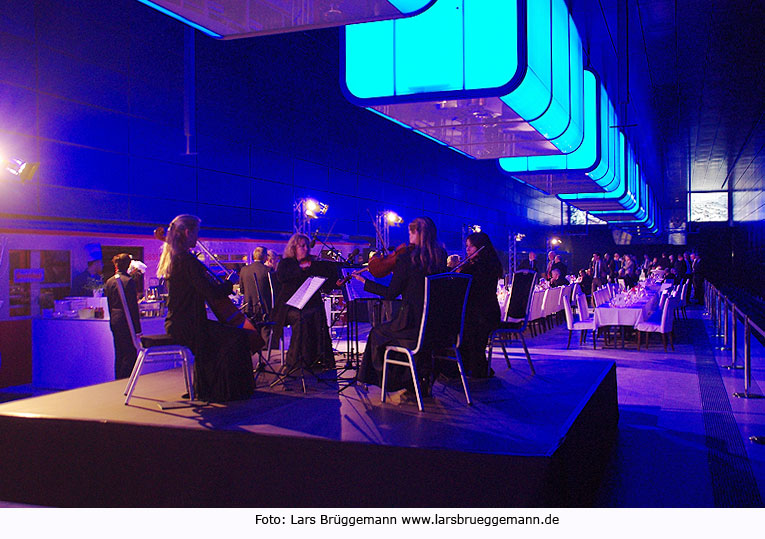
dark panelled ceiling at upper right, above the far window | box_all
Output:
[628,0,765,220]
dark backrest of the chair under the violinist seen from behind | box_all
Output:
[413,273,472,353]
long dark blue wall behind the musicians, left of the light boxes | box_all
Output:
[0,0,560,250]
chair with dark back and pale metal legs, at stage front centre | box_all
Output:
[380,273,473,412]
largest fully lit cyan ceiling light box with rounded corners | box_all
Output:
[342,0,584,158]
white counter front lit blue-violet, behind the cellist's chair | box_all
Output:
[32,318,170,389]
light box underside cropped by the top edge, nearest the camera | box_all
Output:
[138,0,435,39]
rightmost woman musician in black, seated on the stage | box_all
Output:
[457,232,502,378]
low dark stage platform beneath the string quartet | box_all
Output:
[0,359,619,507]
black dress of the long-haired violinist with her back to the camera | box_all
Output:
[357,252,448,391]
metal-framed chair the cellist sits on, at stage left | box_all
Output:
[117,279,194,406]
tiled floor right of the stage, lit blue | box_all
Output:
[508,308,765,507]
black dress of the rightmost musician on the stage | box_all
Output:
[460,258,501,378]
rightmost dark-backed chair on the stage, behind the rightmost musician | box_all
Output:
[489,270,541,374]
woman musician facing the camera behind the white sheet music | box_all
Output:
[273,234,337,373]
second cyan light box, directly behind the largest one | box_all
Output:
[498,70,608,194]
